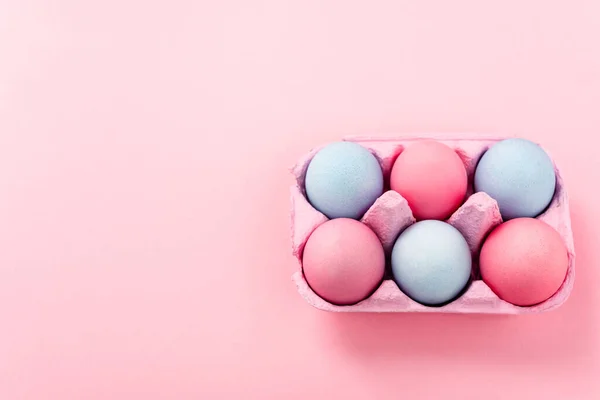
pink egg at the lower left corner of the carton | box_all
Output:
[302,218,385,305]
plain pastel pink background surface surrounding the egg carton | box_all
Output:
[0,0,600,400]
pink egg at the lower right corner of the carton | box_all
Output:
[479,218,569,306]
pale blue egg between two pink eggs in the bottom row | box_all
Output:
[392,220,471,306]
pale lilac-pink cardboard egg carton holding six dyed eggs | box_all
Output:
[291,137,575,314]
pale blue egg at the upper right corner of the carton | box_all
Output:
[474,139,556,221]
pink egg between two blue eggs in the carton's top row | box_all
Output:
[390,140,467,220]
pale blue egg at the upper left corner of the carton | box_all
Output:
[305,142,383,219]
